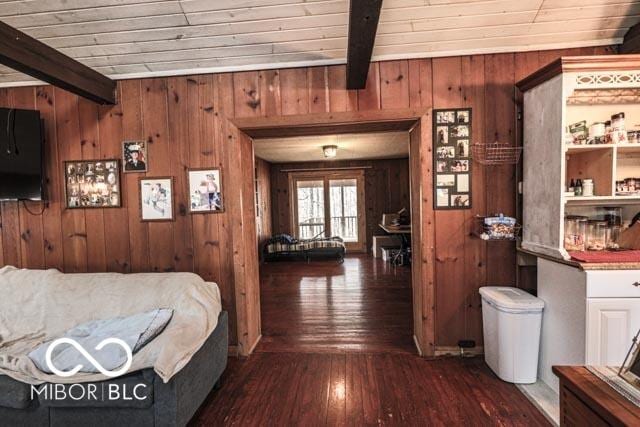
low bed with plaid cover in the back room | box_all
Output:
[263,234,346,263]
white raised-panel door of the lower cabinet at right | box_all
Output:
[586,298,640,366]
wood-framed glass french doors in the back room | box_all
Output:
[289,170,366,251]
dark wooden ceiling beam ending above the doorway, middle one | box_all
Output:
[347,0,382,89]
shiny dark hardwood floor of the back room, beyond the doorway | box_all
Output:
[256,255,417,353]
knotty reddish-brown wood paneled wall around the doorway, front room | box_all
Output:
[0,44,610,352]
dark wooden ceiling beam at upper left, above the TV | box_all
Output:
[0,22,116,104]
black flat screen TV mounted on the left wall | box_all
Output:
[0,108,44,200]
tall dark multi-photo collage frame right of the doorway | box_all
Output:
[432,108,472,210]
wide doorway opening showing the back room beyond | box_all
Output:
[253,131,416,353]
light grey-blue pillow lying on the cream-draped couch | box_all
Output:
[29,308,173,374]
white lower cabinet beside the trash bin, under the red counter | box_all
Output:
[538,258,640,391]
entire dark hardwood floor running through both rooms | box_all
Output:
[191,256,549,427]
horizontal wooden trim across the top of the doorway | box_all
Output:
[231,108,429,138]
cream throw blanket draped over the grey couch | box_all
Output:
[0,267,222,384]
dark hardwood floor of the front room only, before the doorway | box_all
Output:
[193,352,549,426]
